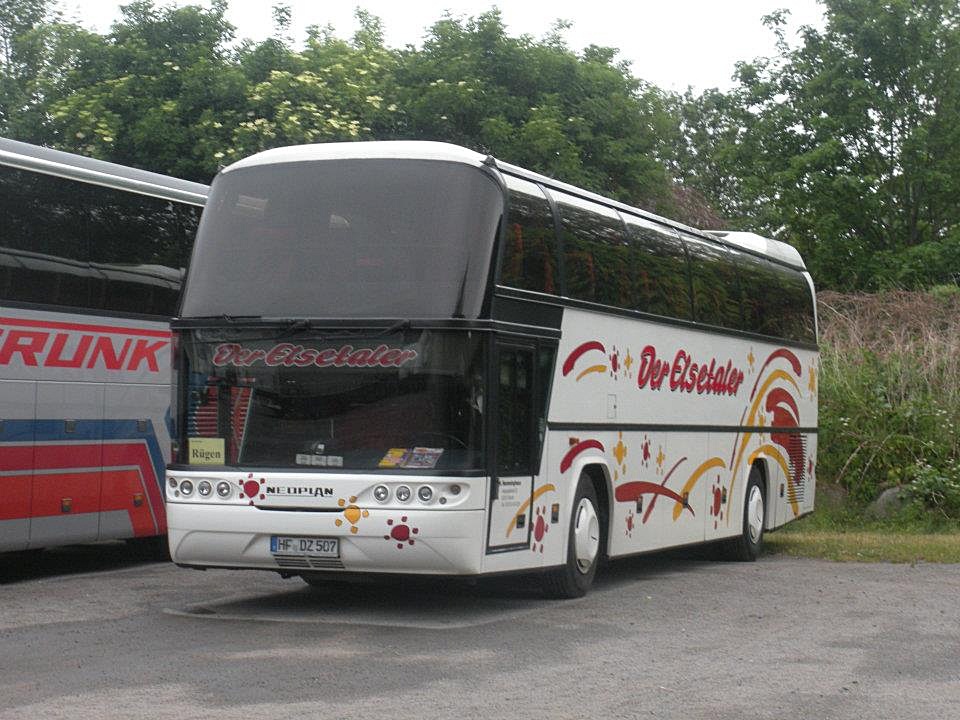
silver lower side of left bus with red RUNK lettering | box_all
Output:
[0,308,170,551]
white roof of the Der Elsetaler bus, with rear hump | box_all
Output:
[221,140,806,270]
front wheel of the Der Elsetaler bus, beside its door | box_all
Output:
[542,473,604,599]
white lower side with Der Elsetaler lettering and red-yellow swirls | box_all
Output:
[540,309,819,558]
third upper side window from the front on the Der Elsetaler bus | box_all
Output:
[623,215,693,320]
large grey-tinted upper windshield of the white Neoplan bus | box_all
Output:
[181,159,503,318]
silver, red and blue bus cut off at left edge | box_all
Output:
[0,139,208,551]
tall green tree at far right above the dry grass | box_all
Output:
[676,0,960,289]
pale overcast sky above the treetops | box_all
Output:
[60,0,823,92]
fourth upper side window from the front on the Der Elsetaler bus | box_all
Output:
[683,235,747,330]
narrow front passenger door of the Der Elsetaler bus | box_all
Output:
[487,342,537,553]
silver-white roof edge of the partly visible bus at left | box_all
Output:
[0,138,209,206]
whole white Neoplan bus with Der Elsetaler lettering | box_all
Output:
[166,142,818,597]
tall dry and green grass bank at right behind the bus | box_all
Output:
[818,287,960,517]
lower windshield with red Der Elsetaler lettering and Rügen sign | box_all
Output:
[180,327,484,472]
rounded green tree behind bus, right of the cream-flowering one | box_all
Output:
[388,10,673,209]
